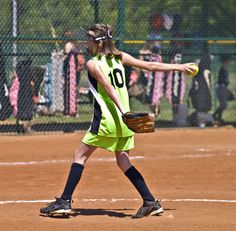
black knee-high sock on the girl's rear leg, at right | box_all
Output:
[125,166,155,201]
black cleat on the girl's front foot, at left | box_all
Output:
[40,198,71,215]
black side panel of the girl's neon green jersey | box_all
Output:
[88,72,102,134]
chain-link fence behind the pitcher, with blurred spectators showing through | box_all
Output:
[0,0,236,133]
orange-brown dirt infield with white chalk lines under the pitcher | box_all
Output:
[0,128,236,231]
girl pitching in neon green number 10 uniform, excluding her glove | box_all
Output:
[40,24,193,218]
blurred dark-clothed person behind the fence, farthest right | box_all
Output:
[213,54,235,123]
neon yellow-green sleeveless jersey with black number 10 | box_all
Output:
[88,56,134,137]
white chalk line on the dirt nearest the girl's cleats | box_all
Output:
[0,198,236,205]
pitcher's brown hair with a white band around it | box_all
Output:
[87,23,121,58]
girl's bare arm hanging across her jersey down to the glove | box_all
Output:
[86,60,127,114]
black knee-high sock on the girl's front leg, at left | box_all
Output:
[61,163,84,200]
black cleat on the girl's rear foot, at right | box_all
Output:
[132,200,164,219]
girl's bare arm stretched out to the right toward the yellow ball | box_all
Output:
[122,52,194,74]
